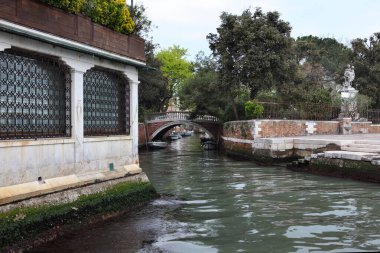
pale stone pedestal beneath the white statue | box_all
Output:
[339,87,359,120]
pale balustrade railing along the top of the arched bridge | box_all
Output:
[145,111,219,122]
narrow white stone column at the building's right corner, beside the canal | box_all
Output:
[129,79,139,164]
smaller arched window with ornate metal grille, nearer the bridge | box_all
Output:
[83,67,130,136]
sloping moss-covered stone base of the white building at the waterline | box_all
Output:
[0,173,158,252]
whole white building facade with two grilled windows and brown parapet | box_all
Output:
[0,0,145,204]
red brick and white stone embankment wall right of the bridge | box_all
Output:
[223,119,380,163]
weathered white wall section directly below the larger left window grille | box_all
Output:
[0,139,75,187]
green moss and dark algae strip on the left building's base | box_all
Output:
[0,182,157,251]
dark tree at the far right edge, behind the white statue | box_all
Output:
[351,32,380,108]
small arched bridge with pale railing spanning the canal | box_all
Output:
[145,111,223,142]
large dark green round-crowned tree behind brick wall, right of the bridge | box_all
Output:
[207,8,296,119]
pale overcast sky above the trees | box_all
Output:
[135,0,380,59]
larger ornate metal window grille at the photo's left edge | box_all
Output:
[0,49,71,139]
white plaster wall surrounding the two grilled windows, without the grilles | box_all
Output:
[0,29,139,187]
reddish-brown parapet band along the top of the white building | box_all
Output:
[0,0,145,62]
